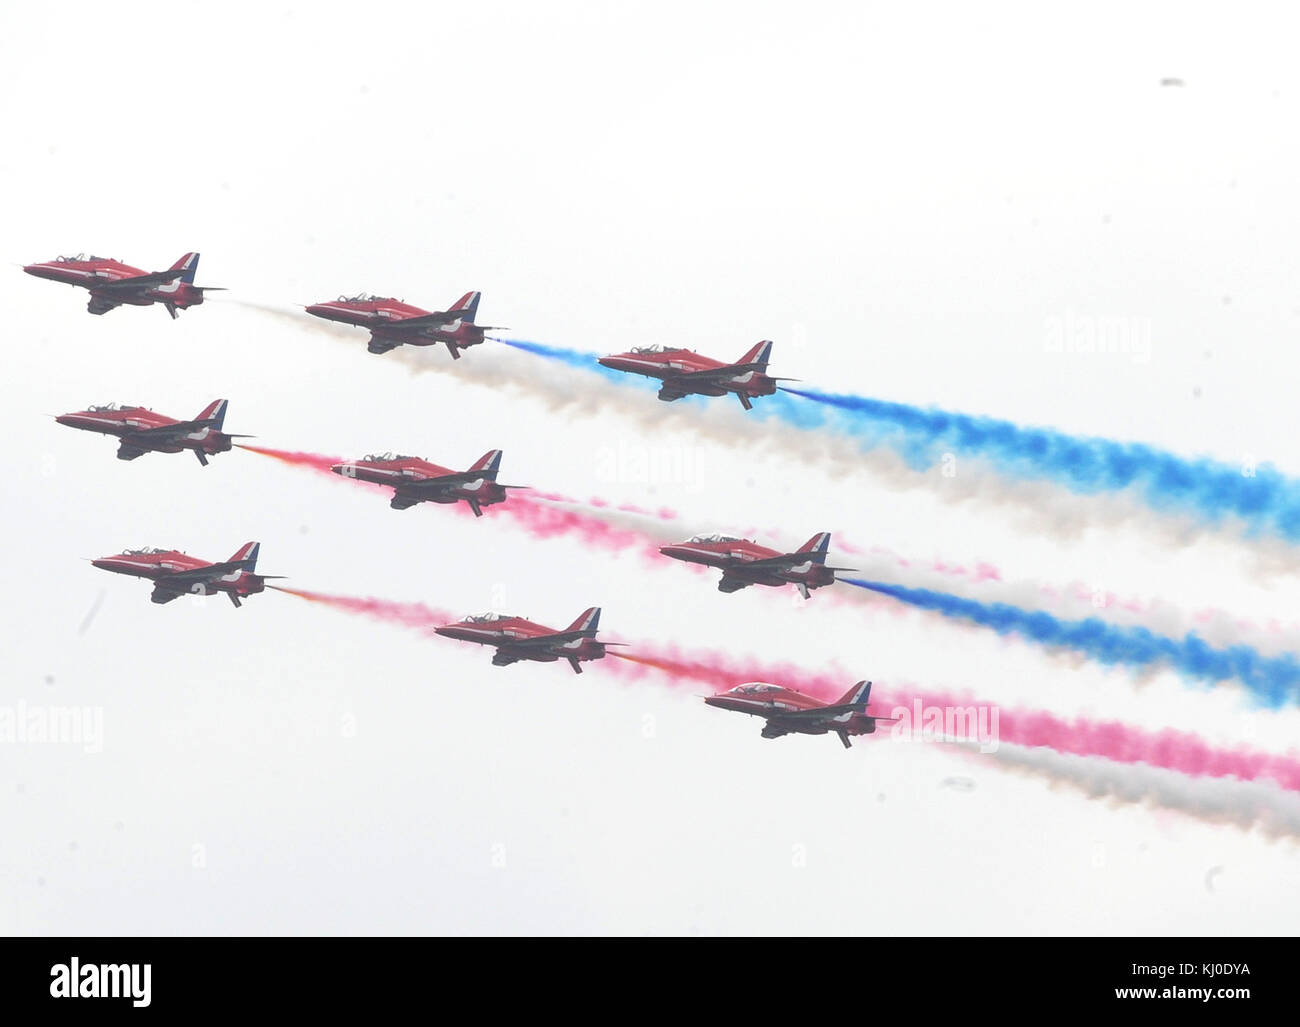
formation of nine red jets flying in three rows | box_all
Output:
[23,252,891,748]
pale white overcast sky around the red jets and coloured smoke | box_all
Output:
[0,3,1300,933]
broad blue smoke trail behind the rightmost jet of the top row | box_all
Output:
[781,389,1300,542]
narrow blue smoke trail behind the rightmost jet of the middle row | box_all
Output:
[840,577,1300,710]
